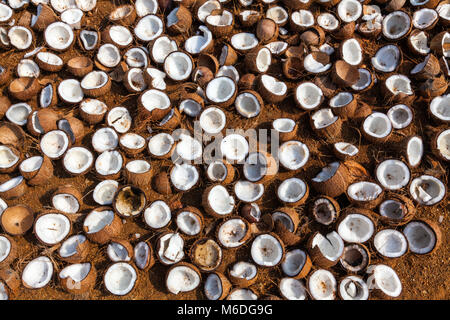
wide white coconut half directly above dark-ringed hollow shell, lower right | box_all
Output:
[337,213,375,243]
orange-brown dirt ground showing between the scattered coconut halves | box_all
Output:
[0,1,450,300]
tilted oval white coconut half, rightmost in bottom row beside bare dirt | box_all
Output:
[367,264,402,298]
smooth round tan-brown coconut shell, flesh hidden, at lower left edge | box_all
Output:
[0,205,34,236]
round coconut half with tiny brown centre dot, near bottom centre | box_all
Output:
[250,234,283,267]
